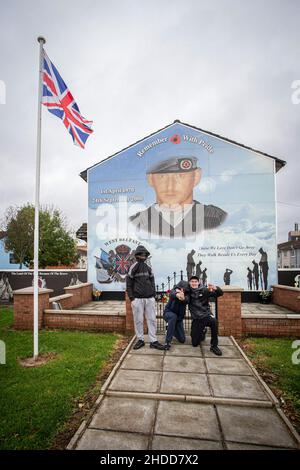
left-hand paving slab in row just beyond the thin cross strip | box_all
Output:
[108,369,161,393]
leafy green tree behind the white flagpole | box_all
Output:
[5,204,78,269]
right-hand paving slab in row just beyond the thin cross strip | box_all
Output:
[209,375,270,401]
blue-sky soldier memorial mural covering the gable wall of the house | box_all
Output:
[88,123,277,291]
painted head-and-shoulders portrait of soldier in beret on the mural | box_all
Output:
[129,157,227,238]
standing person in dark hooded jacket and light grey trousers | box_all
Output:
[126,245,165,349]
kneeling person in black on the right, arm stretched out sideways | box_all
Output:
[189,276,223,356]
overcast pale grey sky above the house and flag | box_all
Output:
[0,0,300,242]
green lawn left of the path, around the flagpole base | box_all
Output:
[0,307,121,449]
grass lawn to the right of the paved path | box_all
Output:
[242,338,300,432]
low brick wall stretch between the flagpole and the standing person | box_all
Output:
[44,311,126,332]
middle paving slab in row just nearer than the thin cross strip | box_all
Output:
[154,401,221,441]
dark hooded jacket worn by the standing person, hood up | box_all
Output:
[126,245,156,300]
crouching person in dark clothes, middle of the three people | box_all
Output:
[164,281,189,350]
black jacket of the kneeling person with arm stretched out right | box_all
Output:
[189,287,223,320]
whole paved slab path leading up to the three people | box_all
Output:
[68,337,299,450]
